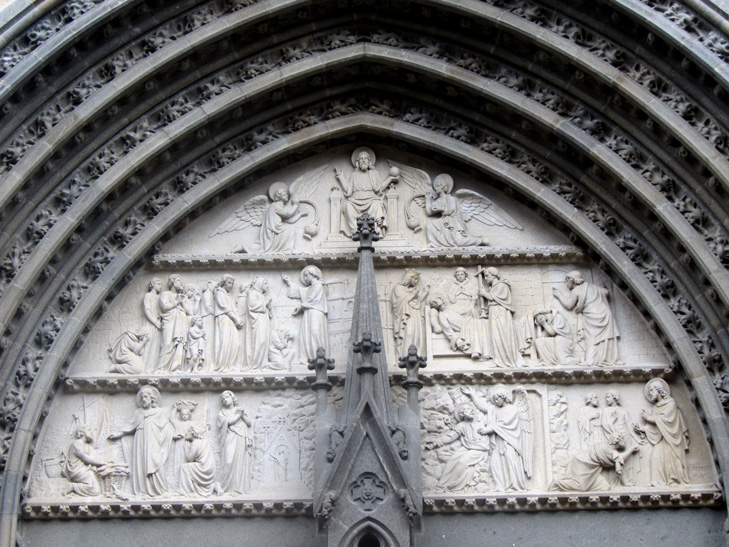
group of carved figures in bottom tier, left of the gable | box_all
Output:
[62,386,253,497]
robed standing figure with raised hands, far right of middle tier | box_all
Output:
[552,271,620,365]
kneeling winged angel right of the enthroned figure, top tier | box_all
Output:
[390,161,522,247]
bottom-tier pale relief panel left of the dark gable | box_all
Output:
[29,385,314,501]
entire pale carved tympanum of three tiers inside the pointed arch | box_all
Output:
[24,147,720,532]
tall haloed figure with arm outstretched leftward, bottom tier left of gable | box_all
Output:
[107,386,174,496]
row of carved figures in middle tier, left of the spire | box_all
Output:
[109,265,329,374]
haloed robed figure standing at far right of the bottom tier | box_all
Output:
[633,378,689,486]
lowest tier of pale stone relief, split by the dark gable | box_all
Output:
[28,378,717,504]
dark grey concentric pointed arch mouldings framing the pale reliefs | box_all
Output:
[0,1,729,543]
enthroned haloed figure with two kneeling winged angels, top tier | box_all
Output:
[211,147,522,253]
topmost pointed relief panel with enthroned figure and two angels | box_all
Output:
[165,146,568,255]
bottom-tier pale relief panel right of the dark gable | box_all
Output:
[421,378,716,495]
